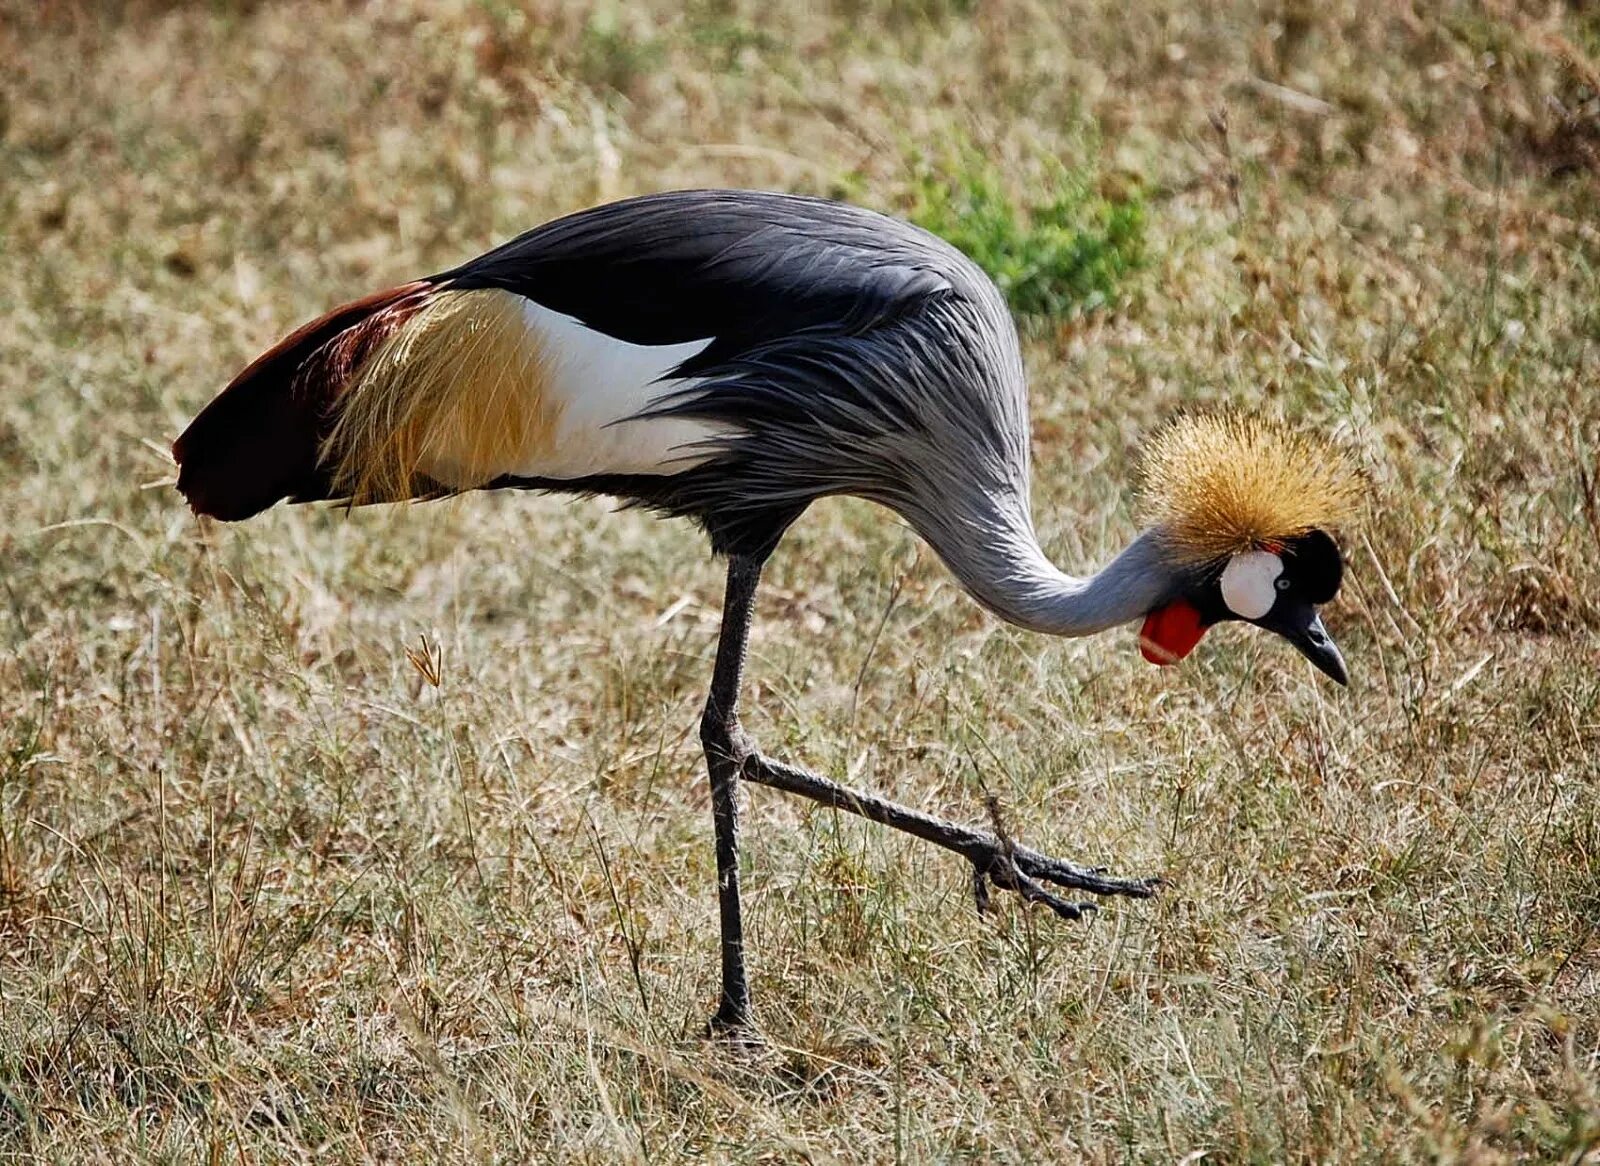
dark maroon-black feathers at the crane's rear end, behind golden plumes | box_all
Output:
[173,280,435,521]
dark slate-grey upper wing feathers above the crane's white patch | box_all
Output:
[437,190,963,376]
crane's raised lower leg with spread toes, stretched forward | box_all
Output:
[741,750,1160,920]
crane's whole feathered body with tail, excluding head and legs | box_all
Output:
[178,190,1062,622]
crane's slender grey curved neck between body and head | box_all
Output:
[906,491,1174,637]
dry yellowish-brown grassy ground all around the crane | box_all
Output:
[0,0,1600,1161]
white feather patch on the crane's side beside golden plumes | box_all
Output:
[510,299,730,478]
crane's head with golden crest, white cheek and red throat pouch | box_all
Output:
[1139,414,1362,685]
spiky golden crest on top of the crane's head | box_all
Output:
[1139,413,1365,563]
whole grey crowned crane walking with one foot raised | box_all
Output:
[173,190,1360,1033]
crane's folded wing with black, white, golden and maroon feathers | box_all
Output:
[174,190,974,518]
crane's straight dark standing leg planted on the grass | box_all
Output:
[701,555,763,1033]
